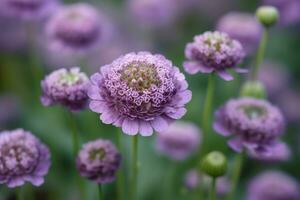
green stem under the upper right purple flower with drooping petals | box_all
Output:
[202,74,215,135]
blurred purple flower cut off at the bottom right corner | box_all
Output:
[247,171,300,200]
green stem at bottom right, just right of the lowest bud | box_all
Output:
[227,153,244,200]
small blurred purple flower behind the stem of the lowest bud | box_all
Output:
[184,169,231,197]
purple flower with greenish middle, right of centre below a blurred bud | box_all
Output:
[214,98,285,155]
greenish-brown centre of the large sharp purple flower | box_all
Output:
[121,62,161,91]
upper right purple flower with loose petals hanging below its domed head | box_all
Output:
[183,31,246,81]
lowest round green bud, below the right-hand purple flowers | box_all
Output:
[201,151,227,178]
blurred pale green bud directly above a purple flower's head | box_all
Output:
[241,81,267,99]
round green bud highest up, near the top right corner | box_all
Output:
[256,6,279,27]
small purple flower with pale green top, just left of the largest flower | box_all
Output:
[41,67,89,111]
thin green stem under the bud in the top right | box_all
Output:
[252,28,269,80]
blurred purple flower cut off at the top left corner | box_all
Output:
[0,0,58,20]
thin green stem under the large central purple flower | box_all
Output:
[130,135,138,200]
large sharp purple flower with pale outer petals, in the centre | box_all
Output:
[88,52,192,136]
